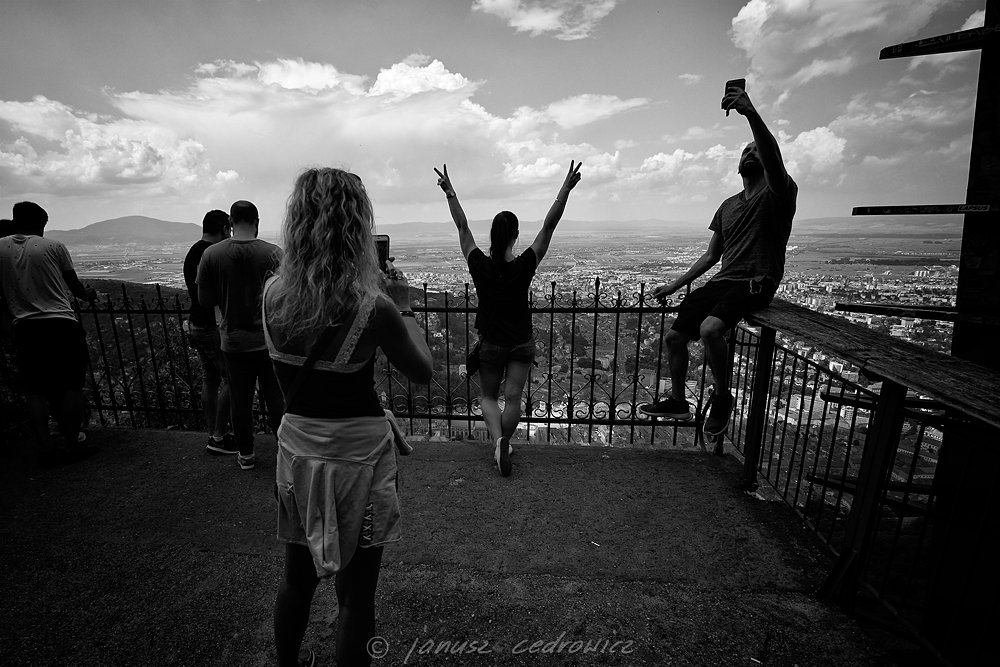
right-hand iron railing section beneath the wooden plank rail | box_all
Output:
[726,326,996,663]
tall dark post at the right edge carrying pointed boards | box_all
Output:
[921,6,1000,665]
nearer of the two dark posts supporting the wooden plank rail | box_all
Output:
[819,380,906,608]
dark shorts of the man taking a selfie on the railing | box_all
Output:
[670,279,778,340]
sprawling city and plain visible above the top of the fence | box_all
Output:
[62,216,961,353]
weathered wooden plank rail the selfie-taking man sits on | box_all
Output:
[747,299,1000,429]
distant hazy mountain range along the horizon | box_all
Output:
[45,215,962,246]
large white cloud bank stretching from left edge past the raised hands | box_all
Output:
[0,54,647,220]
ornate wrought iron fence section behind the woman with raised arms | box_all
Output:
[3,279,706,446]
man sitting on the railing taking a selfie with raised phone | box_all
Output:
[639,86,798,437]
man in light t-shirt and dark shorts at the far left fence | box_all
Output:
[0,202,97,467]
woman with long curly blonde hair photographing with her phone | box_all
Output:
[263,168,431,665]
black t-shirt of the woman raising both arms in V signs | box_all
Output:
[469,248,538,346]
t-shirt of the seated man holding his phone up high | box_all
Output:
[708,177,799,285]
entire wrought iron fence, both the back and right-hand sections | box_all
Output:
[0,280,996,657]
